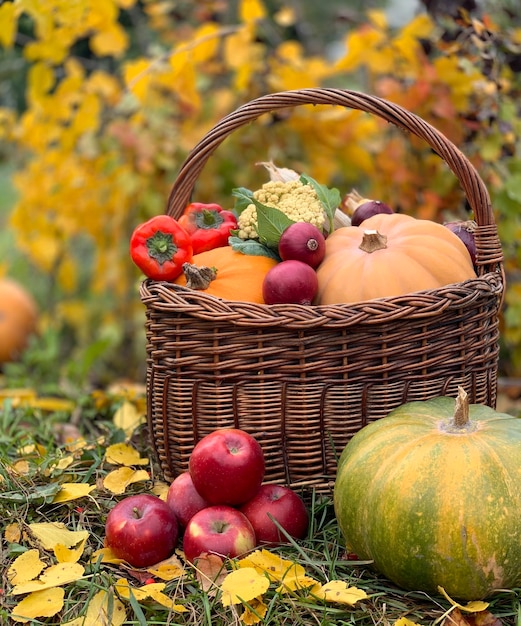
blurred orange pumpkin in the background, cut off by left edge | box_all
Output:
[0,278,38,363]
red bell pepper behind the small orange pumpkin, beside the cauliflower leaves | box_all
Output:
[179,202,237,254]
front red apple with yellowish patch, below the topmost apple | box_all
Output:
[183,504,257,563]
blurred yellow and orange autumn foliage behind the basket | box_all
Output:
[0,0,521,384]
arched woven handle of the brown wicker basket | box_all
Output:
[166,88,503,270]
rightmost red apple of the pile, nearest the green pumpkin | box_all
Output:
[240,484,309,545]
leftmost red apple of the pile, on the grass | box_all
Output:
[105,494,179,567]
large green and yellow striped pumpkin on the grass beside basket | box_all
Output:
[334,389,521,600]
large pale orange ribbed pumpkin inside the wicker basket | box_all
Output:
[316,214,476,304]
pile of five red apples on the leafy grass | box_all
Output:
[105,428,309,567]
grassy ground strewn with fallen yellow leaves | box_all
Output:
[0,385,521,626]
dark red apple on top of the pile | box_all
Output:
[188,428,265,506]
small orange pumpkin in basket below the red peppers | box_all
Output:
[174,246,277,304]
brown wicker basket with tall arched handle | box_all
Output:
[140,89,504,491]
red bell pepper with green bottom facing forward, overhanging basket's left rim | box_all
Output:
[130,215,193,280]
